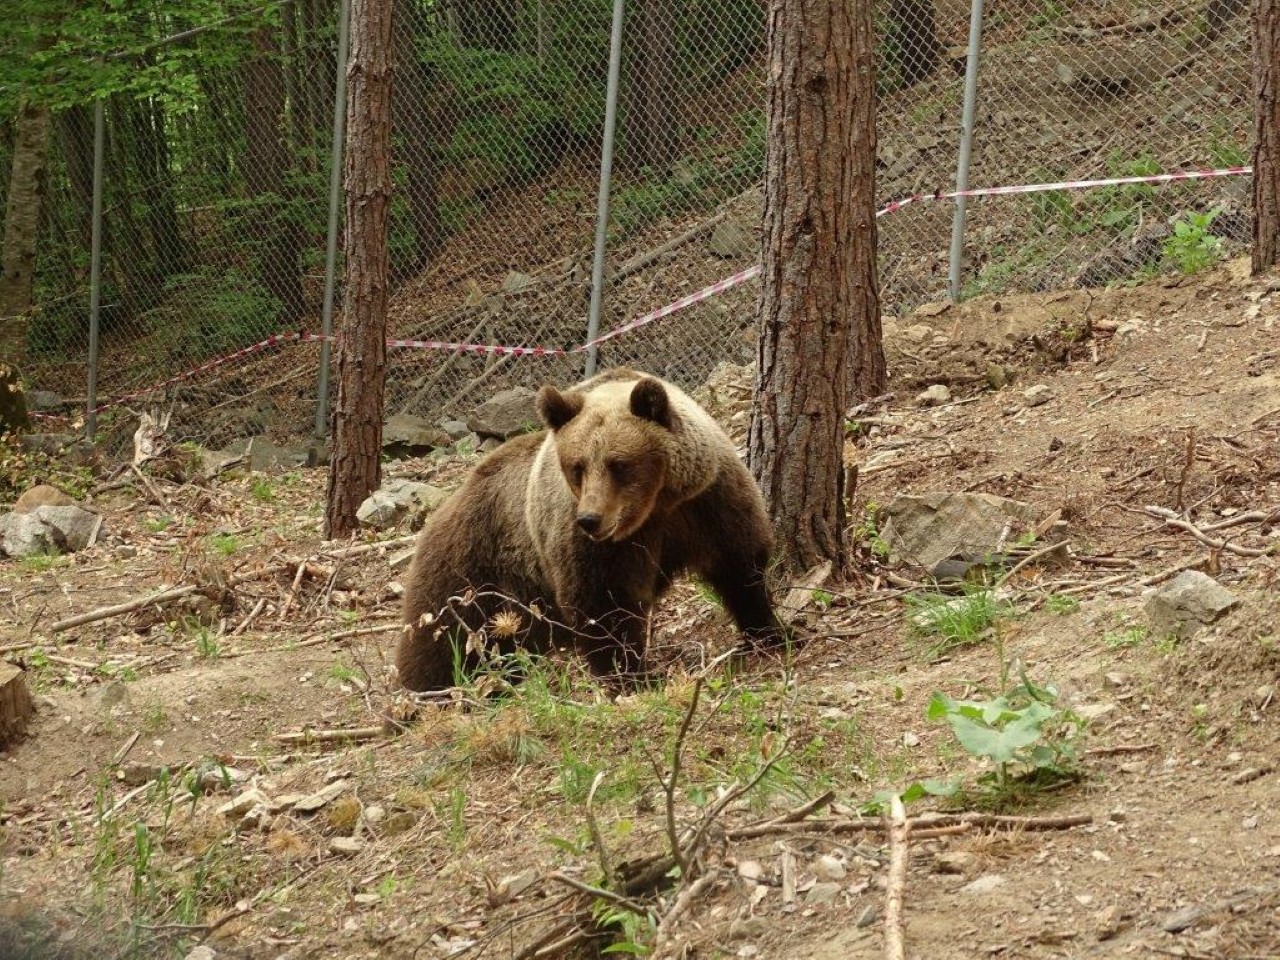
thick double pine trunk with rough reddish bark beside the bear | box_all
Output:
[749,0,884,571]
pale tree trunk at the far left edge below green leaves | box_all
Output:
[0,104,50,369]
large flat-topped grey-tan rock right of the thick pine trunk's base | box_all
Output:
[881,493,1037,575]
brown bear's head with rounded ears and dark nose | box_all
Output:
[538,376,676,543]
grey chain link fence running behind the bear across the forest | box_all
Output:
[0,0,1251,455]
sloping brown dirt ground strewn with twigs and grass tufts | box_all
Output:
[0,262,1280,960]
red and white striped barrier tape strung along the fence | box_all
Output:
[62,166,1253,420]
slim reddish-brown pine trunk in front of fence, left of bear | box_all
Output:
[325,0,394,539]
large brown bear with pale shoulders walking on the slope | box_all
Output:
[397,369,786,690]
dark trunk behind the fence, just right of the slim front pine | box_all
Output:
[392,6,453,276]
